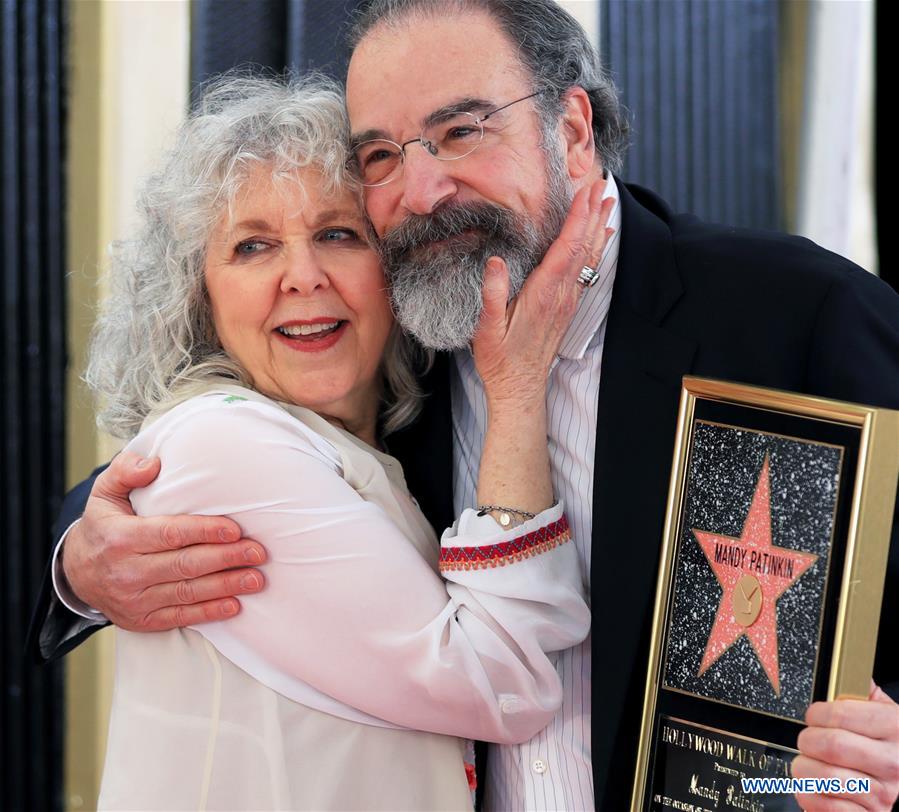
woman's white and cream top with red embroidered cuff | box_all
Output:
[100,385,589,809]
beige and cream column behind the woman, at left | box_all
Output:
[65,0,189,810]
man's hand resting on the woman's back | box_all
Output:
[62,452,265,632]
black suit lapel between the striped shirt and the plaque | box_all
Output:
[591,183,695,809]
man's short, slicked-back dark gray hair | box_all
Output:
[349,0,630,172]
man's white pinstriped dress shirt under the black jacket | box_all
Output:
[452,175,621,812]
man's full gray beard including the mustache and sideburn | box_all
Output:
[379,153,573,350]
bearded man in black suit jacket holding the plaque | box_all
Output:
[29,0,899,811]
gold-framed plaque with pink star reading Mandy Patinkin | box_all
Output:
[631,378,899,812]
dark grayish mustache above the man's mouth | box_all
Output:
[378,201,518,263]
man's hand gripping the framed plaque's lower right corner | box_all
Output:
[793,683,899,812]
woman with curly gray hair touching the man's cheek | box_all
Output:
[87,77,605,810]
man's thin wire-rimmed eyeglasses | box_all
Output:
[350,90,544,186]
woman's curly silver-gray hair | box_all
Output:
[85,73,430,438]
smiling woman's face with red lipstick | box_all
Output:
[205,166,393,430]
